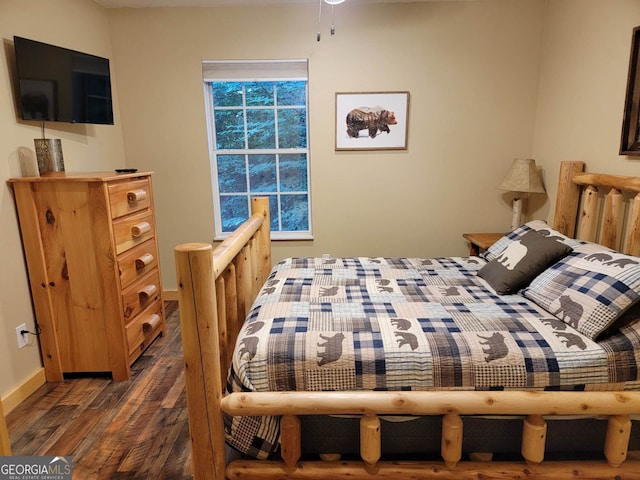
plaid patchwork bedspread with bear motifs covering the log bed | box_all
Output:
[226,257,640,458]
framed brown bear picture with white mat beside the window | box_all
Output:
[336,92,409,150]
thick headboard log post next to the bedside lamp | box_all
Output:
[553,162,584,238]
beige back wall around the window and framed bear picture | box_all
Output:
[110,0,544,289]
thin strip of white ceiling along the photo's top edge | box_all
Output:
[94,0,442,8]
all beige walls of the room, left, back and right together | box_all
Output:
[0,0,640,404]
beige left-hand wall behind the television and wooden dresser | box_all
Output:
[0,0,124,398]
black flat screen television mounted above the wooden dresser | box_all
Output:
[13,37,113,125]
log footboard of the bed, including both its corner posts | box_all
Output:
[175,197,271,480]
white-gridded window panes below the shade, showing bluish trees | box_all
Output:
[210,77,311,238]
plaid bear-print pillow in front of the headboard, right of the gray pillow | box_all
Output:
[522,244,640,340]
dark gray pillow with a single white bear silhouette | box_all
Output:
[478,230,572,295]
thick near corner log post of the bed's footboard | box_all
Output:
[175,243,226,480]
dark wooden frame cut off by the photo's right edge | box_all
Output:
[620,26,640,155]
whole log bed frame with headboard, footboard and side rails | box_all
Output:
[175,162,640,480]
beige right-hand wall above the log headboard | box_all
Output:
[532,0,640,215]
